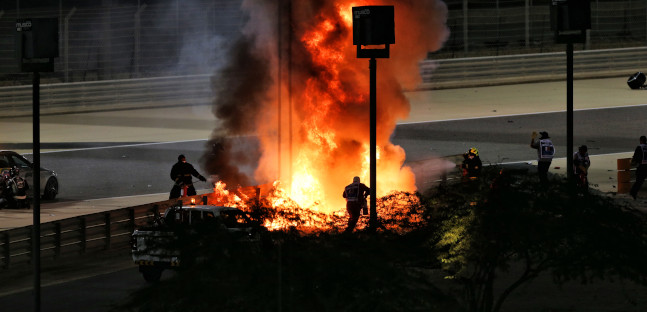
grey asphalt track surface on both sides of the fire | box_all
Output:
[7,106,647,202]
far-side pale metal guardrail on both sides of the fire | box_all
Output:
[0,47,647,117]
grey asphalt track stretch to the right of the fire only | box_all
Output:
[392,106,647,163]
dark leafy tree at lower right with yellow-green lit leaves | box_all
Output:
[426,167,647,312]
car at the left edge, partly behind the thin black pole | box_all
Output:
[0,150,58,199]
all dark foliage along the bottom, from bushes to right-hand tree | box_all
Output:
[119,167,647,312]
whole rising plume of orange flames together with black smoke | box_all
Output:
[202,0,449,213]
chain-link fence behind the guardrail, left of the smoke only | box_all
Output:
[0,0,245,84]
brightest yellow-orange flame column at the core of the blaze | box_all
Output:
[268,1,415,213]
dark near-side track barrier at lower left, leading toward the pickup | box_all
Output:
[0,195,195,270]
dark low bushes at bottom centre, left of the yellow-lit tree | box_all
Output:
[119,231,457,312]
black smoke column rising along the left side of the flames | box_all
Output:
[200,35,273,187]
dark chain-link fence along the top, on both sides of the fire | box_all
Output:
[0,0,647,86]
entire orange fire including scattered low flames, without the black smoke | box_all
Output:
[208,0,448,232]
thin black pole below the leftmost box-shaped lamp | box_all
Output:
[31,72,40,312]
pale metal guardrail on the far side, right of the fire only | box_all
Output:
[419,47,647,89]
